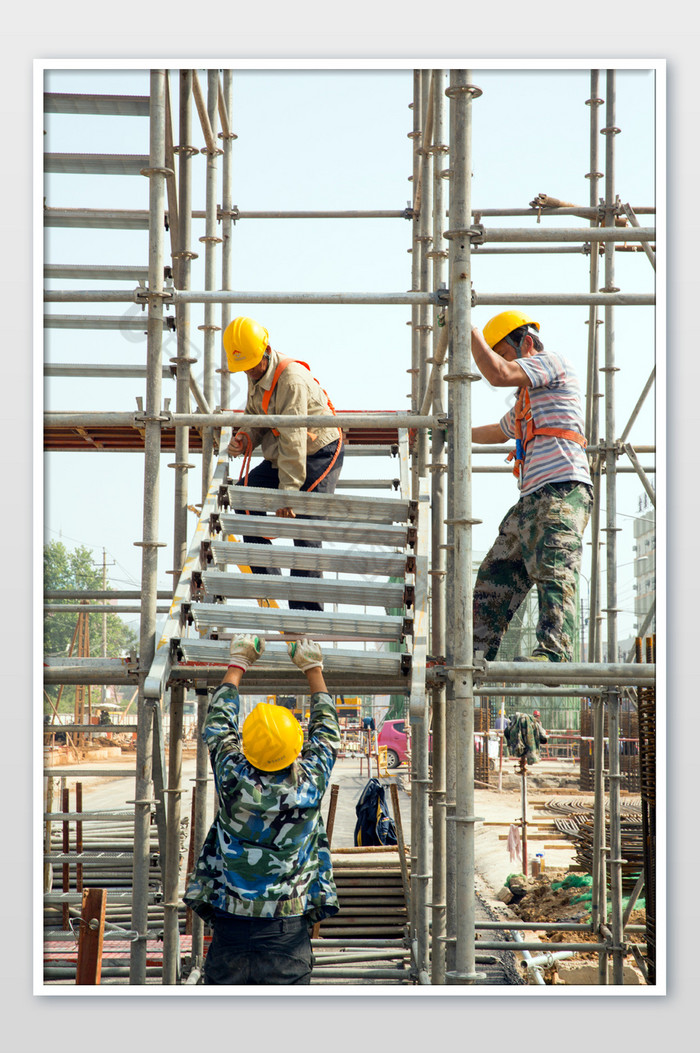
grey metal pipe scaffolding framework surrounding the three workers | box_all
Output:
[44,68,656,986]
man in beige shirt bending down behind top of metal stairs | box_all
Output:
[223,317,343,611]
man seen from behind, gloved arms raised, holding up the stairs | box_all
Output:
[184,635,340,985]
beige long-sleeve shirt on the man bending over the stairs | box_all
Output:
[240,349,339,490]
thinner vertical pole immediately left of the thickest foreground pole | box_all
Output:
[429,69,448,985]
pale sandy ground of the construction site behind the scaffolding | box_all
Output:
[42,739,644,985]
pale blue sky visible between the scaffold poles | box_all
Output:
[42,63,664,637]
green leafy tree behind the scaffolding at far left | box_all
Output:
[44,541,138,710]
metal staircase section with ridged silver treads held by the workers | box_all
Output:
[145,431,427,697]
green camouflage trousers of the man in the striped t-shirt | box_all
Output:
[474,482,593,661]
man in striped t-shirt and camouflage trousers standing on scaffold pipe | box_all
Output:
[472,311,593,662]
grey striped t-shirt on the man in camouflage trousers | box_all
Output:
[500,351,591,496]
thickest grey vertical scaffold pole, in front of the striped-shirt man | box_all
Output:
[445,69,481,984]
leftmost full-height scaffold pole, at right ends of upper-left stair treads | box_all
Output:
[129,69,165,985]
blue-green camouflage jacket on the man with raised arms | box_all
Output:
[183,684,340,922]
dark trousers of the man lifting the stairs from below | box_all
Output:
[204,914,314,985]
